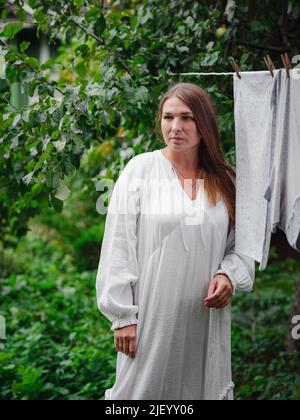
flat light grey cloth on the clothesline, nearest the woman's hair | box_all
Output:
[234,70,278,270]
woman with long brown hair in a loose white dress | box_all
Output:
[96,83,255,400]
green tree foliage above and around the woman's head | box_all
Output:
[0,0,300,243]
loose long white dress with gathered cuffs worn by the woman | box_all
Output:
[96,150,255,400]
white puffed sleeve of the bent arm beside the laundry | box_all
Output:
[215,229,255,293]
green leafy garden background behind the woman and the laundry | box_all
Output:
[0,0,300,400]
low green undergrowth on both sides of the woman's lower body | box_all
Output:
[0,233,300,400]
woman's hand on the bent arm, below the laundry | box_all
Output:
[204,274,233,309]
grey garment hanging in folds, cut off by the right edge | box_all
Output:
[262,69,300,268]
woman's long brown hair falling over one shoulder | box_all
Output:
[156,83,236,227]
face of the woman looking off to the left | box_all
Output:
[161,96,201,151]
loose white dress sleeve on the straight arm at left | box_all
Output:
[96,158,140,330]
